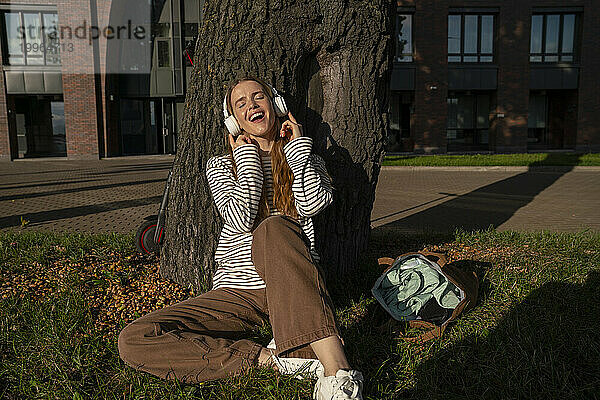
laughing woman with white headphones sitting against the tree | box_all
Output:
[119,77,363,400]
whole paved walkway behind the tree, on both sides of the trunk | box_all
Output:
[0,155,600,233]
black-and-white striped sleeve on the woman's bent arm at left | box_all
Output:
[206,143,263,232]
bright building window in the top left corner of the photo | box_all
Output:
[1,11,60,65]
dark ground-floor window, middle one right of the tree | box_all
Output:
[446,93,490,151]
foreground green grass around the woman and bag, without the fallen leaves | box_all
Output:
[0,228,600,400]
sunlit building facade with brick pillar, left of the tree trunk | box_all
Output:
[0,0,203,161]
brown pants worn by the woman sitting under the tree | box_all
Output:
[118,215,339,383]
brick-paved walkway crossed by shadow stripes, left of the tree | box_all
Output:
[0,155,174,232]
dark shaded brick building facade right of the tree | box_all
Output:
[387,0,600,153]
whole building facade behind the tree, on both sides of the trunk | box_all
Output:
[0,0,600,161]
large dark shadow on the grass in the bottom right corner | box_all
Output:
[405,271,600,399]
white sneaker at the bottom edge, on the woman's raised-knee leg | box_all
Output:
[313,369,364,400]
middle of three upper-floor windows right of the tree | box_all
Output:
[448,14,494,62]
